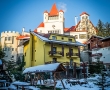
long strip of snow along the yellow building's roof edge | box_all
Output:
[31,32,85,46]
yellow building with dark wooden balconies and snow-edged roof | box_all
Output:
[24,32,83,68]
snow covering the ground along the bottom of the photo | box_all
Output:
[7,75,110,90]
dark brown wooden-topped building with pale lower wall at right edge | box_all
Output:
[88,36,110,67]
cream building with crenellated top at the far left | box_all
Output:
[1,31,20,62]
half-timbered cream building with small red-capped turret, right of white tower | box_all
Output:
[65,12,97,44]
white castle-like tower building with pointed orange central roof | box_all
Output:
[34,4,64,34]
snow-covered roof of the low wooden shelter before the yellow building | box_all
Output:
[23,63,60,74]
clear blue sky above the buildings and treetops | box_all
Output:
[0,0,110,32]
